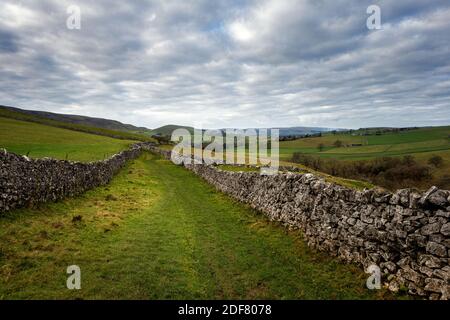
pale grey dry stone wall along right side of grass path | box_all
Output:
[150,149,450,299]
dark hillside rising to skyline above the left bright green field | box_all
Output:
[0,106,153,141]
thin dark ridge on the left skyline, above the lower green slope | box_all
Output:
[0,106,149,132]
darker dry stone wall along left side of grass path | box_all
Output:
[0,143,155,212]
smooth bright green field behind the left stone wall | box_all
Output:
[0,117,135,161]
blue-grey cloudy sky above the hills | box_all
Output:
[0,0,450,128]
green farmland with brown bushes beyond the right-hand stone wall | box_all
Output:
[280,126,450,190]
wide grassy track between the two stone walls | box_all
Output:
[0,154,400,299]
